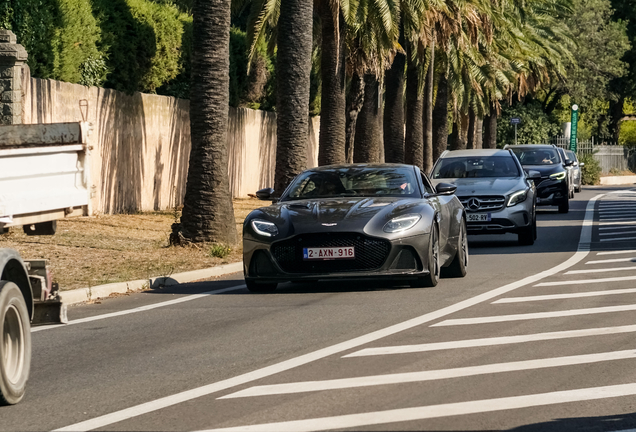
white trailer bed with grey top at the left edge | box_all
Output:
[0,122,91,235]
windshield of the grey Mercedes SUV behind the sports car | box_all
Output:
[433,156,521,179]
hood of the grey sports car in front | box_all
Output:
[248,197,423,236]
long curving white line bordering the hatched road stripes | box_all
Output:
[56,194,604,431]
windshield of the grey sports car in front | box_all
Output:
[282,167,419,201]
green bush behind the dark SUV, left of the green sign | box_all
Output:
[497,102,561,147]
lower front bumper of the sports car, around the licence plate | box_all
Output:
[243,232,429,283]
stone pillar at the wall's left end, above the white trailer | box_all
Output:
[0,29,28,125]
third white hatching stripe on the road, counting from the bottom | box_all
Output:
[343,325,636,358]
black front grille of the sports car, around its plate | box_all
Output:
[271,233,391,273]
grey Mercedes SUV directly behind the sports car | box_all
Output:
[431,149,540,245]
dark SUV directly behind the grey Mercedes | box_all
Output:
[505,144,572,213]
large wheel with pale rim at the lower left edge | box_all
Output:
[0,281,31,405]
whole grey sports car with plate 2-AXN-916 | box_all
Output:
[243,164,468,292]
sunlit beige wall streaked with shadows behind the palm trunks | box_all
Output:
[23,69,319,213]
